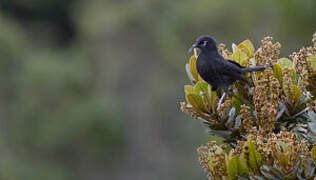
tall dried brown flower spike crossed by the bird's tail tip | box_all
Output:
[253,36,281,133]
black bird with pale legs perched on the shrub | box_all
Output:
[189,35,265,109]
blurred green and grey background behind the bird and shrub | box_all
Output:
[0,0,316,180]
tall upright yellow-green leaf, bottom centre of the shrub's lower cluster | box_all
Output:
[243,139,262,174]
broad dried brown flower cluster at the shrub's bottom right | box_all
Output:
[235,130,310,174]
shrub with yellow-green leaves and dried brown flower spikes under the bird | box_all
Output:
[180,32,316,179]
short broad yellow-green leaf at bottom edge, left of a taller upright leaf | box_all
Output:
[227,155,249,180]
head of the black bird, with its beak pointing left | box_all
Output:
[189,35,217,52]
